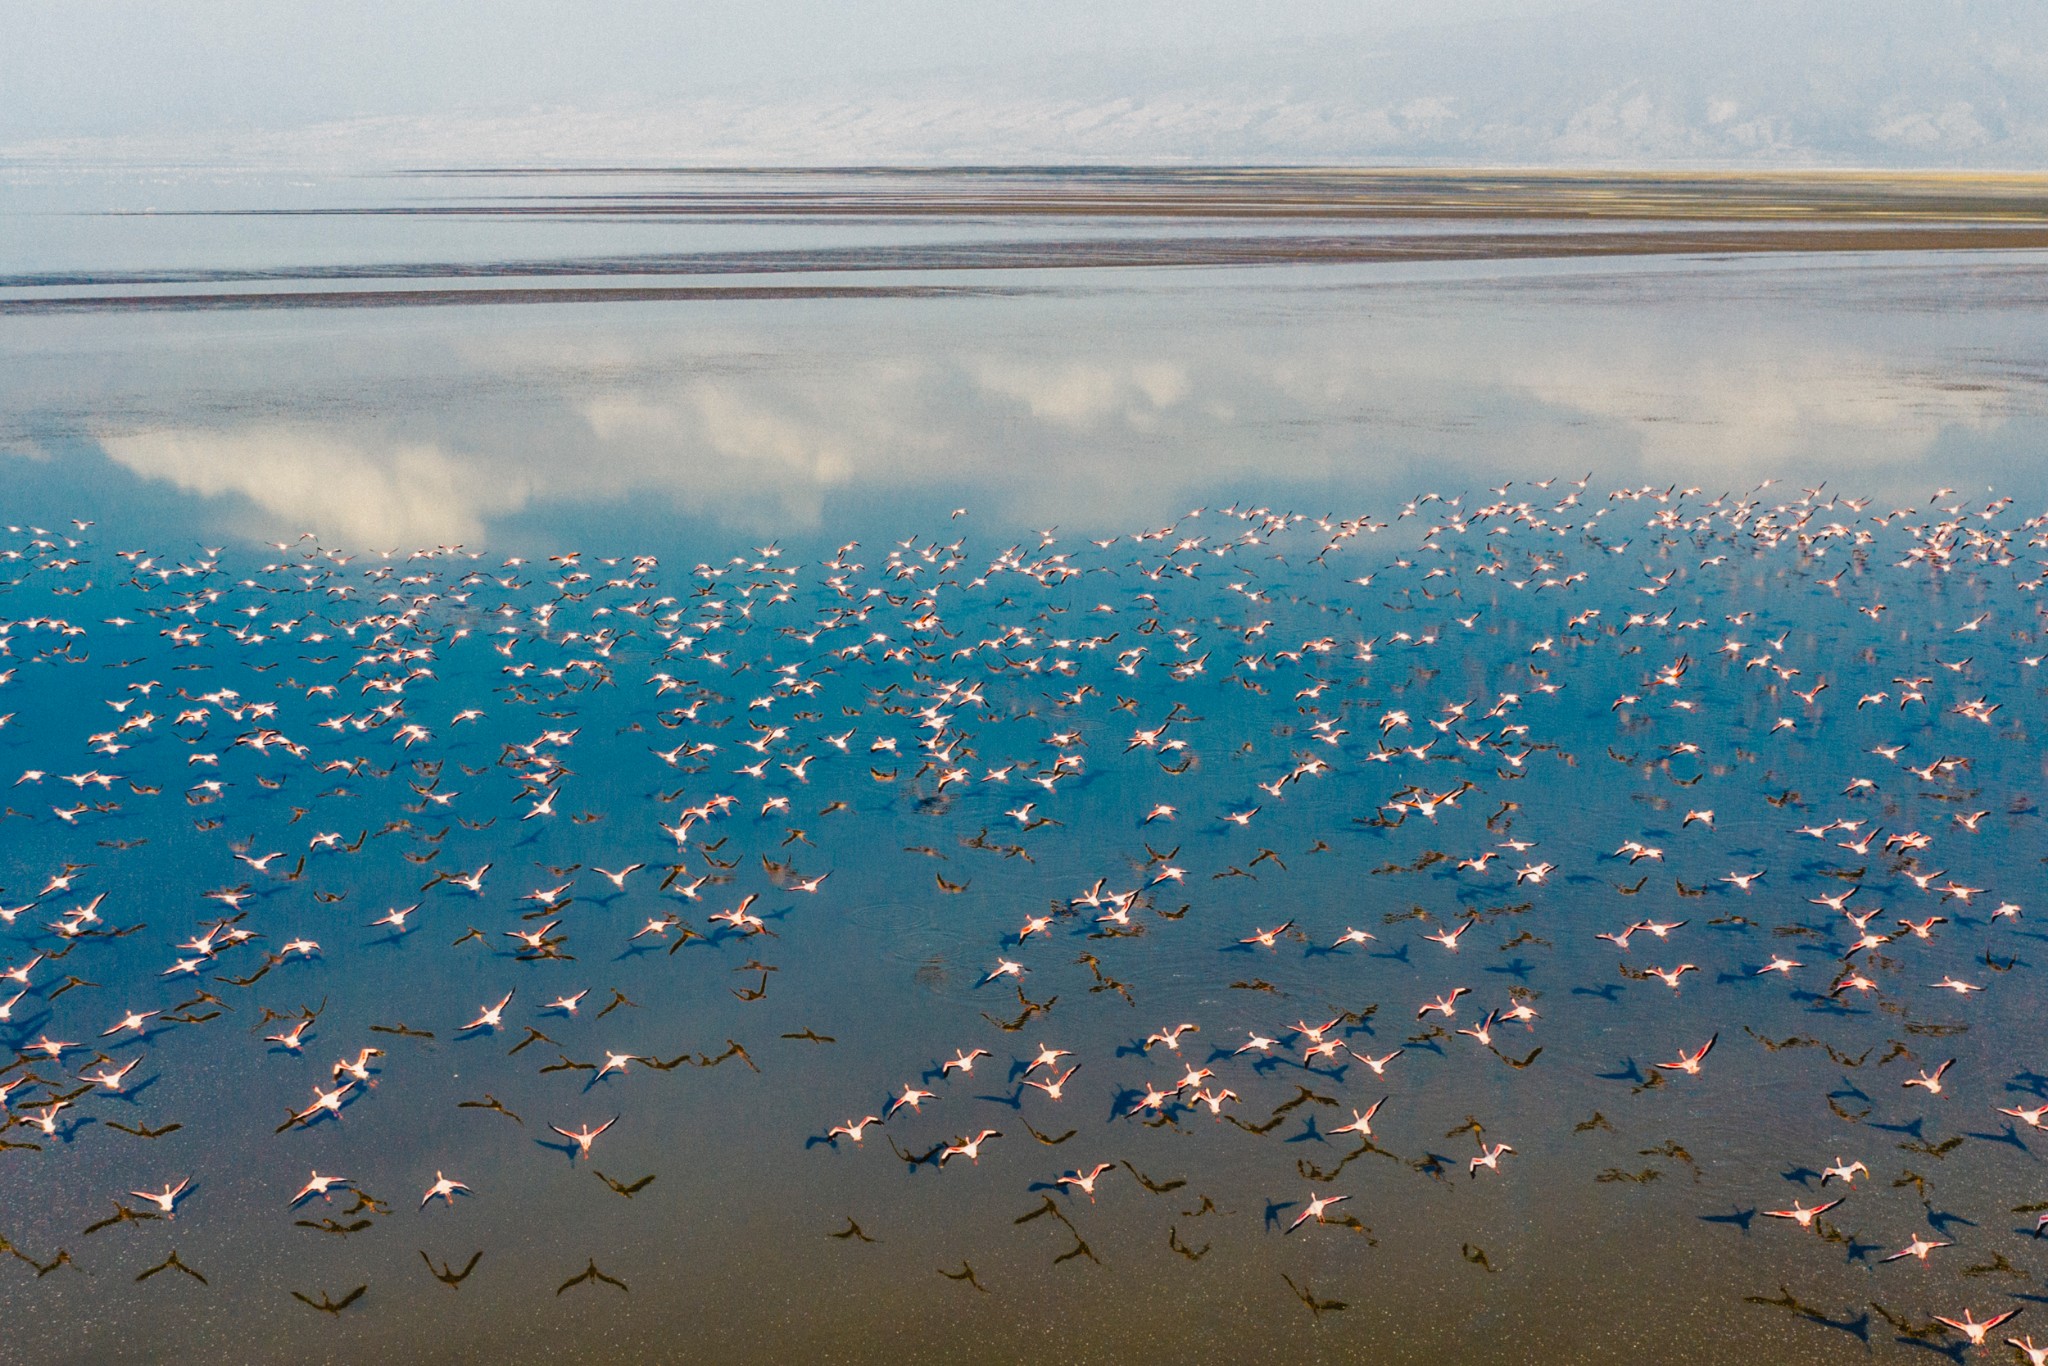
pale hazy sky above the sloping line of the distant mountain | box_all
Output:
[0,0,1585,137]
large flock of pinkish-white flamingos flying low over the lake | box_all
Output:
[0,477,2048,1364]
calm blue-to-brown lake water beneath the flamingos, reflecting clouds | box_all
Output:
[0,178,2048,1362]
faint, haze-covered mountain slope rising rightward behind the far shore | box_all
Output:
[0,0,2048,170]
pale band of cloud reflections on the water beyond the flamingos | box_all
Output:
[0,259,2048,547]
